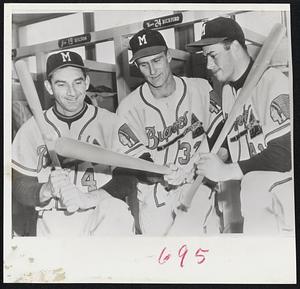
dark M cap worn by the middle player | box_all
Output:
[129,29,168,62]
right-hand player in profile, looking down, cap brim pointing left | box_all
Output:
[188,17,294,234]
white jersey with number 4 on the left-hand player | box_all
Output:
[12,104,143,233]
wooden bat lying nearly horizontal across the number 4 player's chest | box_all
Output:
[54,137,171,174]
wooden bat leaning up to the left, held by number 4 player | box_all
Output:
[15,60,78,212]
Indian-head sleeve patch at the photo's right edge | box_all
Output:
[270,94,290,124]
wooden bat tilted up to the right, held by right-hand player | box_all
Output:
[178,23,286,211]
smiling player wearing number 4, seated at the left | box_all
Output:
[12,51,143,236]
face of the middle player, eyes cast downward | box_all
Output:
[136,51,172,88]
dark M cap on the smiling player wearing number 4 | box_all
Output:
[46,51,87,78]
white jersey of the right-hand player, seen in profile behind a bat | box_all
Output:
[222,68,290,162]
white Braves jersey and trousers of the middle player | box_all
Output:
[117,77,223,235]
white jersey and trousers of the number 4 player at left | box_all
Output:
[12,104,143,236]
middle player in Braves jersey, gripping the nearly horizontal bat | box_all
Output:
[117,29,223,235]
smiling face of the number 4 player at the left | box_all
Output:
[45,66,90,116]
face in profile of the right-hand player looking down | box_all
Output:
[203,43,235,82]
